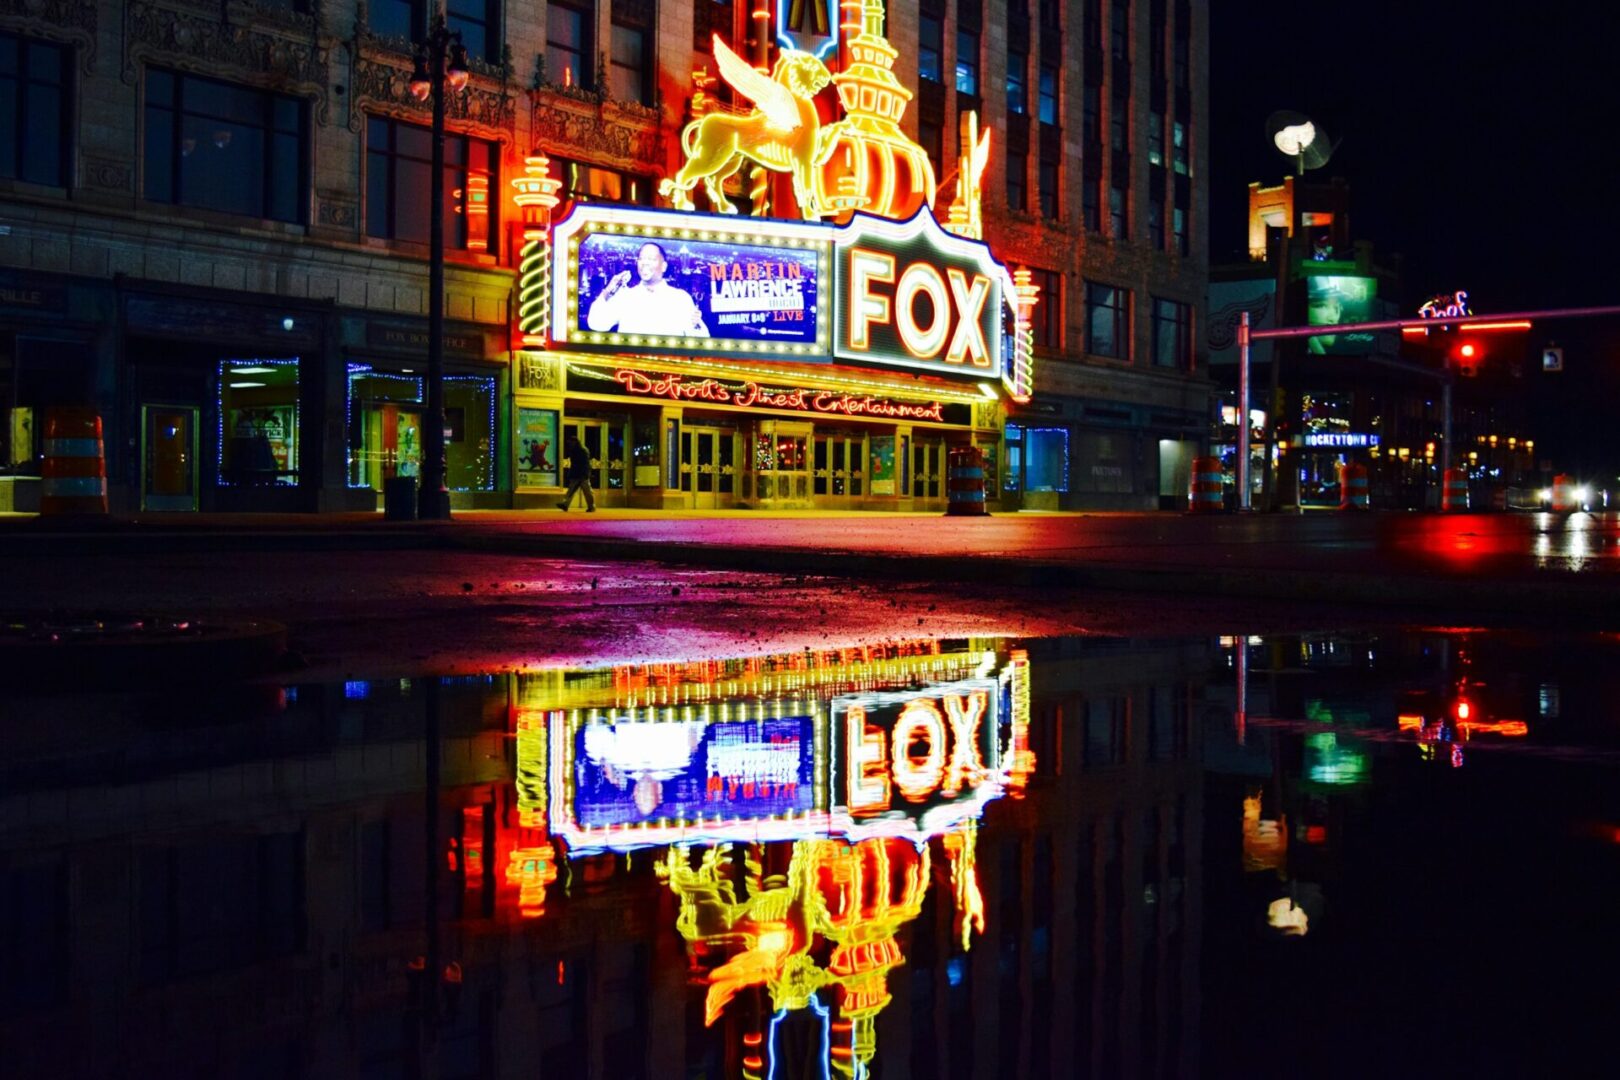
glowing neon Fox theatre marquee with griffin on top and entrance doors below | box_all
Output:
[512,0,1037,510]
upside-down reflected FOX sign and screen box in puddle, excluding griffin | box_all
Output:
[531,649,1029,855]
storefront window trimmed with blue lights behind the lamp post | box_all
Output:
[348,364,489,491]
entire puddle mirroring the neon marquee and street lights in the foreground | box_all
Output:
[0,630,1620,1078]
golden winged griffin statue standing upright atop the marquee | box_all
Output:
[658,34,833,220]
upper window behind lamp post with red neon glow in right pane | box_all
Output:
[366,117,501,251]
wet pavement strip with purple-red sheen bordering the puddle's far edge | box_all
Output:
[5,551,1412,675]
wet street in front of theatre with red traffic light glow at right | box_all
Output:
[0,510,1620,622]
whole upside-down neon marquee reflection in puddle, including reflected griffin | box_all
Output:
[507,641,1035,1078]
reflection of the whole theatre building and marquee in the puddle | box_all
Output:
[0,641,1202,1078]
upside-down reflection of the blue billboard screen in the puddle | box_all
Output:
[573,717,815,829]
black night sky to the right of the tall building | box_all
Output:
[1210,0,1620,474]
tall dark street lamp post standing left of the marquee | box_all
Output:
[410,11,467,521]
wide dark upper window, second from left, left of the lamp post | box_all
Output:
[144,70,309,223]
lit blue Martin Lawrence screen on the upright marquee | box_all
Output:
[573,232,821,345]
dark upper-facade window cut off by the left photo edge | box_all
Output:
[0,34,73,188]
